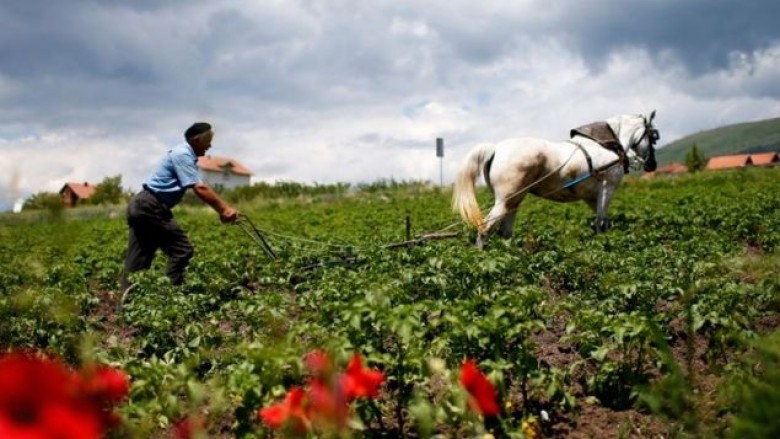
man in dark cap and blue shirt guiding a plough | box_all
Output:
[120,122,238,292]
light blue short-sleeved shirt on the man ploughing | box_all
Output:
[144,143,203,207]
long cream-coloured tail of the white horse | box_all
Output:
[452,143,495,232]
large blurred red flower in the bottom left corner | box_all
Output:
[0,353,102,439]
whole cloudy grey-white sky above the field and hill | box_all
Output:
[0,0,780,209]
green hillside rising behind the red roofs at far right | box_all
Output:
[656,118,780,166]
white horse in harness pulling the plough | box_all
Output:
[452,110,659,248]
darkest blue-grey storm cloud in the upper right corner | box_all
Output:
[550,0,780,75]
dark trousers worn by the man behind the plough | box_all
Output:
[119,189,194,291]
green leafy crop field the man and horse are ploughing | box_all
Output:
[0,168,780,438]
